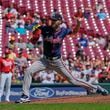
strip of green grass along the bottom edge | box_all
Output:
[0,103,110,110]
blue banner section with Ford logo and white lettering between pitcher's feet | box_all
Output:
[30,87,87,98]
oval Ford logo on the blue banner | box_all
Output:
[30,87,55,98]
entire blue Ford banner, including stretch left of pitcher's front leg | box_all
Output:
[3,86,87,101]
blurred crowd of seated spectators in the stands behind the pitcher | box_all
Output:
[1,0,110,84]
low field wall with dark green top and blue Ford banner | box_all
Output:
[2,83,110,101]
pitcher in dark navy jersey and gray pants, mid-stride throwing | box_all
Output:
[15,17,108,103]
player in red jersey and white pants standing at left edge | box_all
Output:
[0,49,14,102]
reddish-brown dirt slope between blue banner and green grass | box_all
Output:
[31,95,110,103]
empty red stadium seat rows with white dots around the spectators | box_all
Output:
[0,0,110,59]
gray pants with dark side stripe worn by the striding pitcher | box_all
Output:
[23,58,97,96]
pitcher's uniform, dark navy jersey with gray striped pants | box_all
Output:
[23,26,97,96]
